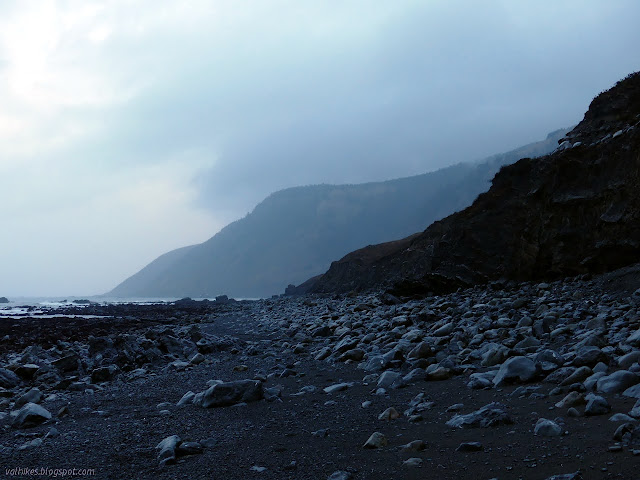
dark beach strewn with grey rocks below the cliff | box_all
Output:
[0,266,640,480]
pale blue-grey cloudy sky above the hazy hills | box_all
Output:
[0,0,640,297]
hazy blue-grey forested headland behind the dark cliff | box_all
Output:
[108,130,566,298]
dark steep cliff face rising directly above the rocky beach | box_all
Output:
[307,73,640,294]
